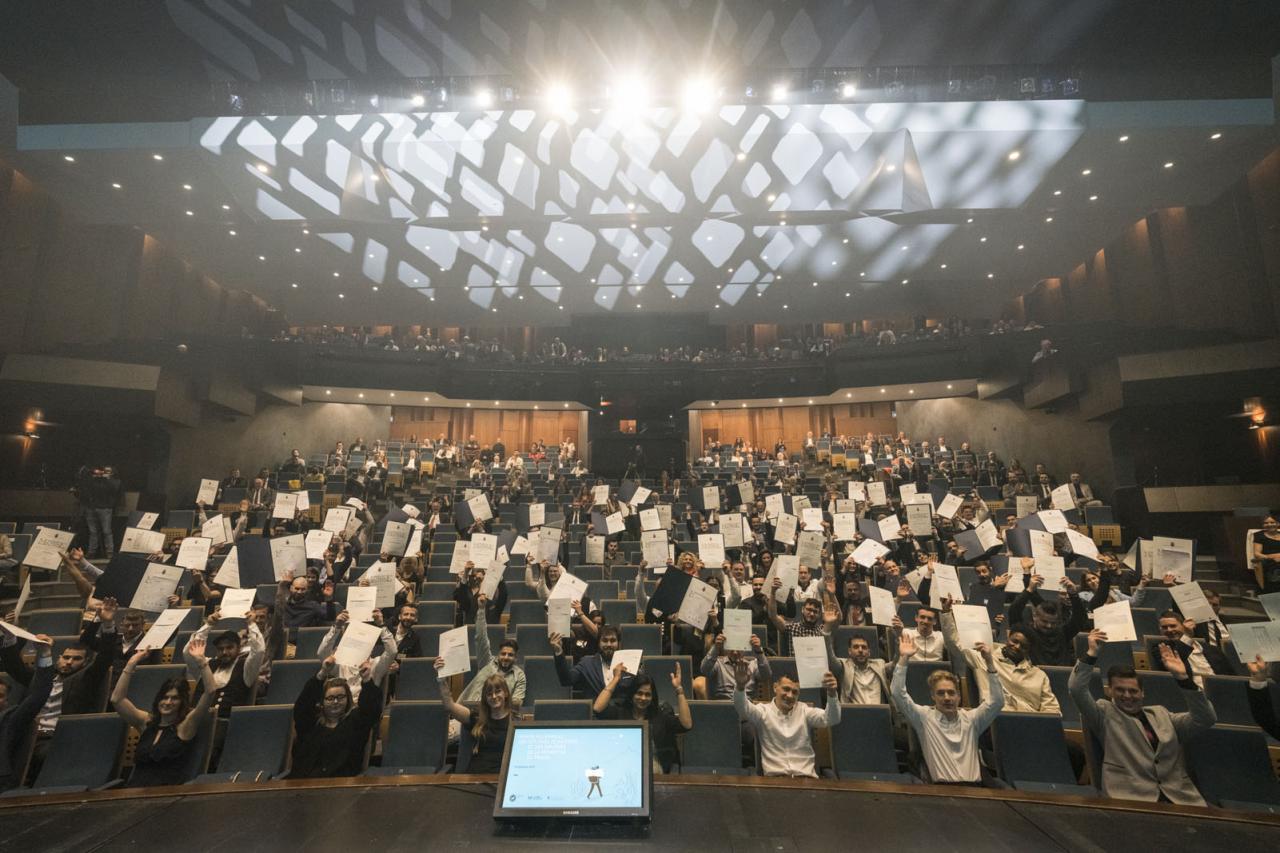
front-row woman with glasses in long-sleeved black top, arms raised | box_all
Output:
[289,654,383,779]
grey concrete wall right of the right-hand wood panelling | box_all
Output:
[897,397,1116,501]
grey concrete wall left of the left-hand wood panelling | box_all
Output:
[165,403,392,506]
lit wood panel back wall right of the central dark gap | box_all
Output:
[696,402,896,450]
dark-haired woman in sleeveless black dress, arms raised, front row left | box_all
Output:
[111,638,218,788]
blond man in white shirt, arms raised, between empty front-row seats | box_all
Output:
[890,634,1005,785]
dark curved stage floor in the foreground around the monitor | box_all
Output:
[0,777,1280,853]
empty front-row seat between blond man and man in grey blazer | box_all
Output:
[991,711,1098,797]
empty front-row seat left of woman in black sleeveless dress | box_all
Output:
[0,713,127,797]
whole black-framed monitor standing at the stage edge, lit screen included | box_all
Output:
[493,720,653,821]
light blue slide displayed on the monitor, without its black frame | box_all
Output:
[503,727,644,808]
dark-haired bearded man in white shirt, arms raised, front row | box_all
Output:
[733,660,840,779]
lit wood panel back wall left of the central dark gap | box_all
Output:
[390,406,585,455]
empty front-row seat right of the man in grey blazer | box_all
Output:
[1187,725,1280,815]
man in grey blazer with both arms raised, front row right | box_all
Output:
[1068,629,1217,806]
